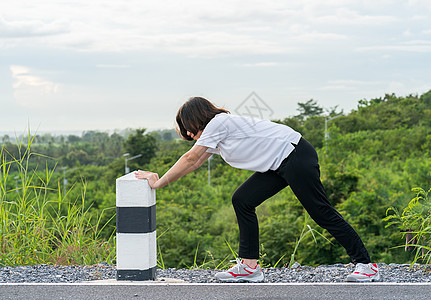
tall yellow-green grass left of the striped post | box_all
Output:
[0,134,115,266]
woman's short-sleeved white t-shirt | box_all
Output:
[196,113,301,172]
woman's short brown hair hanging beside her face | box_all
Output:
[176,97,229,141]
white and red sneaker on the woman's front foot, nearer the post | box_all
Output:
[215,258,265,282]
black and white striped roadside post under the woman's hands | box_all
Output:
[116,172,157,281]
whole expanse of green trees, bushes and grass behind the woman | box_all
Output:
[0,91,431,268]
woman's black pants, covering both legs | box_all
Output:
[232,138,370,263]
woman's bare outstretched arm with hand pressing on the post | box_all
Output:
[135,145,211,189]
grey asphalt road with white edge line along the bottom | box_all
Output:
[0,283,431,300]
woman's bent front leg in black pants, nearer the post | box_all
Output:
[232,171,287,259]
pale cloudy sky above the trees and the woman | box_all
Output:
[0,0,431,133]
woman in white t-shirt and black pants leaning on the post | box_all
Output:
[135,97,380,282]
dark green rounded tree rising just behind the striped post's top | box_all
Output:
[124,128,157,166]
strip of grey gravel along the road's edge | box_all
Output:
[0,263,431,283]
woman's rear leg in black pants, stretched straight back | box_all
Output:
[276,139,370,263]
